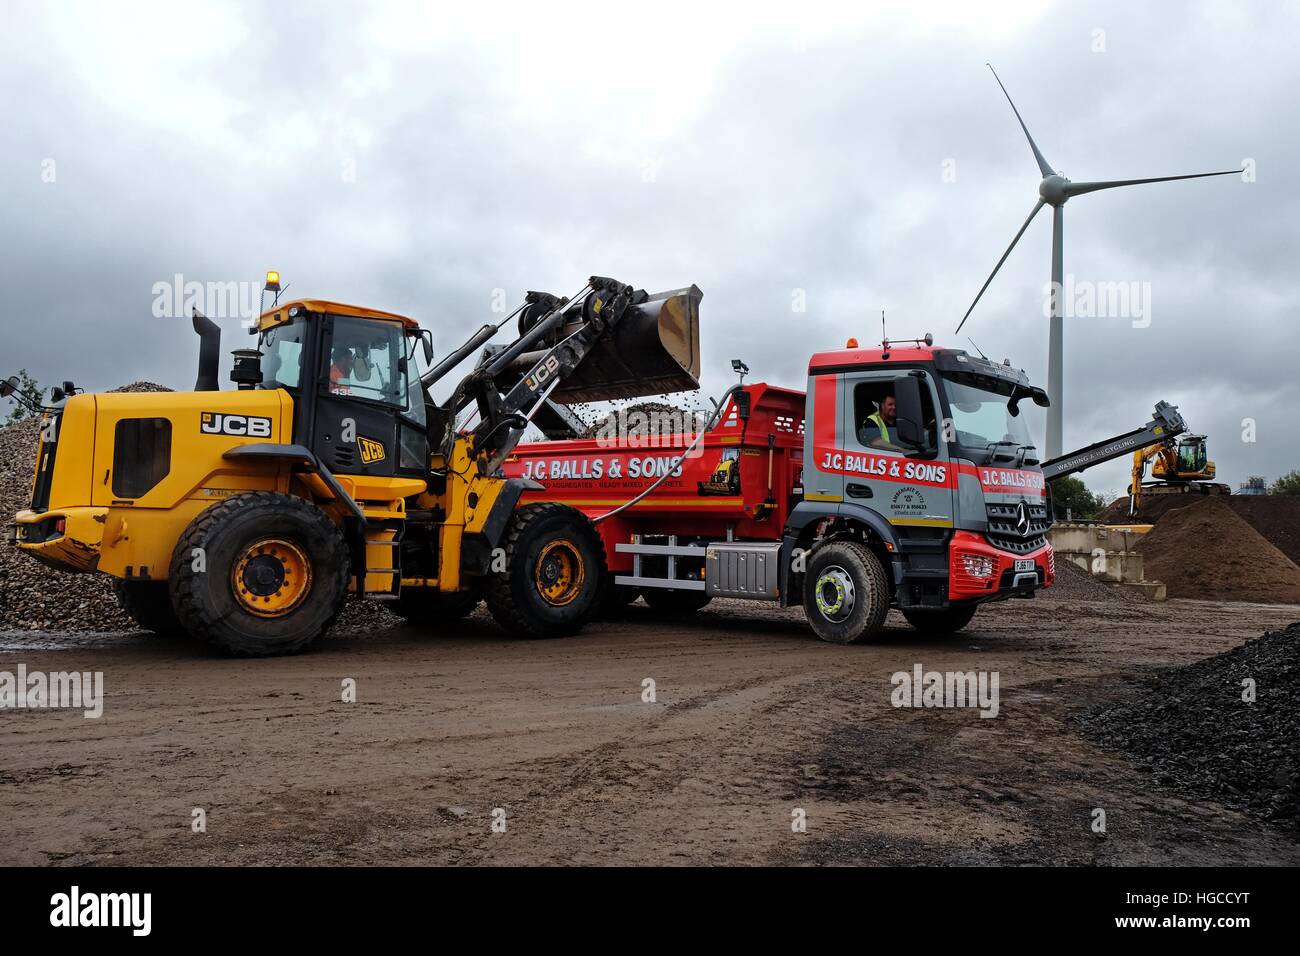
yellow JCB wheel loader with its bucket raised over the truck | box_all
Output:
[0,273,701,656]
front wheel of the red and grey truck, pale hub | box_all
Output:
[803,541,889,644]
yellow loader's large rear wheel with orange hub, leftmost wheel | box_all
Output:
[172,492,350,657]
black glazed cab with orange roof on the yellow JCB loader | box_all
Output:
[257,300,429,477]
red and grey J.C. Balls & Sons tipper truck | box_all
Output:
[504,337,1054,644]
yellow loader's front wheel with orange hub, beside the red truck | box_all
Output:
[484,501,605,637]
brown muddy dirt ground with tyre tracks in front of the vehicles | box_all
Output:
[0,600,1300,866]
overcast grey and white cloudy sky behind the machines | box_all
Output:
[0,1,1300,492]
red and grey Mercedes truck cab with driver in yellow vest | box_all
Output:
[784,337,1054,639]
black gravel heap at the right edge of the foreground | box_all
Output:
[1078,624,1300,835]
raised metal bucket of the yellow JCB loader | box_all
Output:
[551,286,705,405]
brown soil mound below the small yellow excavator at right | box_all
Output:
[1138,498,1300,604]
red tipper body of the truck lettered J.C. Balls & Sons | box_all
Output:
[504,384,805,572]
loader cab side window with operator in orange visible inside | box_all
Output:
[325,316,410,408]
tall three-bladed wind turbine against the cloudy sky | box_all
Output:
[957,64,1243,458]
